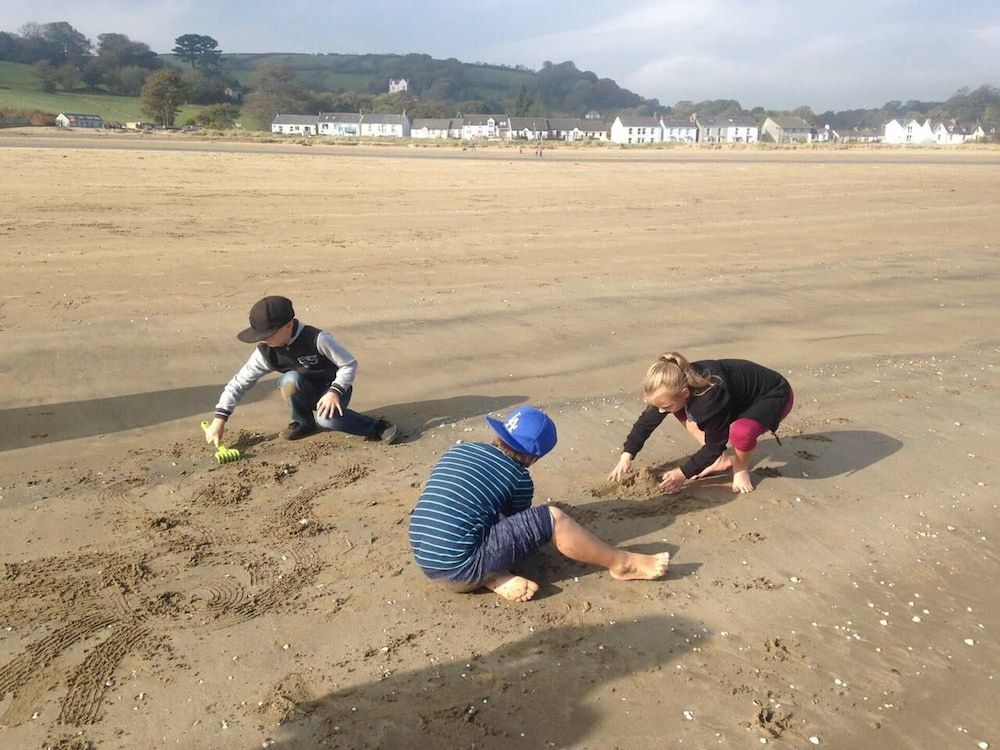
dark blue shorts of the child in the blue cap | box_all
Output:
[424,505,552,591]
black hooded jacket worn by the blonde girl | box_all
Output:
[622,359,792,479]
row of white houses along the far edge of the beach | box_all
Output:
[271,112,986,145]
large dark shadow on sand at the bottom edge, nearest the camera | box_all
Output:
[265,616,703,750]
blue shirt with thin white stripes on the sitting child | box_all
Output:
[410,443,535,570]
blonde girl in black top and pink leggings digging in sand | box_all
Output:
[608,352,794,493]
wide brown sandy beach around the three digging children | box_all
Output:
[0,131,1000,750]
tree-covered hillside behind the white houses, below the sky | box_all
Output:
[0,21,1000,135]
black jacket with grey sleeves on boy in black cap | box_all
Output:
[215,321,358,420]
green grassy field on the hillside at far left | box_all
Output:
[0,62,201,122]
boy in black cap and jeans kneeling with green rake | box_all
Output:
[205,296,398,445]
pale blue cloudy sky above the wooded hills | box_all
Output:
[0,0,1000,113]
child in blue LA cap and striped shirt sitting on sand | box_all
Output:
[410,406,670,602]
